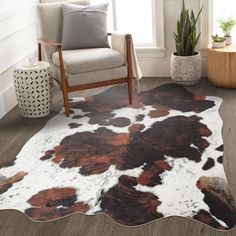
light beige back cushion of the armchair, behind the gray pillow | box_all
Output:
[38,0,90,63]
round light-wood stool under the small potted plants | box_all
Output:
[207,45,236,88]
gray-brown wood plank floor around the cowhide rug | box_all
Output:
[0,78,236,236]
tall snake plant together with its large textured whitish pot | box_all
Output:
[171,0,203,85]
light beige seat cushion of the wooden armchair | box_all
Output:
[52,48,125,74]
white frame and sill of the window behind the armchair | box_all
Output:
[112,0,166,58]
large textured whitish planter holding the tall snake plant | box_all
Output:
[171,53,202,85]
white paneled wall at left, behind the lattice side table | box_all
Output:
[0,0,37,118]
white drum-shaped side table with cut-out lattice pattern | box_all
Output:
[13,61,52,118]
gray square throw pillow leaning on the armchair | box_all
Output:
[62,3,109,49]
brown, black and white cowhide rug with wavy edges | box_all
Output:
[0,84,236,230]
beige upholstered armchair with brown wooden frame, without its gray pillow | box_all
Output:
[38,0,133,116]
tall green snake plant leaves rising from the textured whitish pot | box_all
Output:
[173,0,203,56]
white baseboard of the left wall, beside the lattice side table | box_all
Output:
[0,82,17,119]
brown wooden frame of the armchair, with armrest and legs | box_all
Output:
[38,34,133,117]
